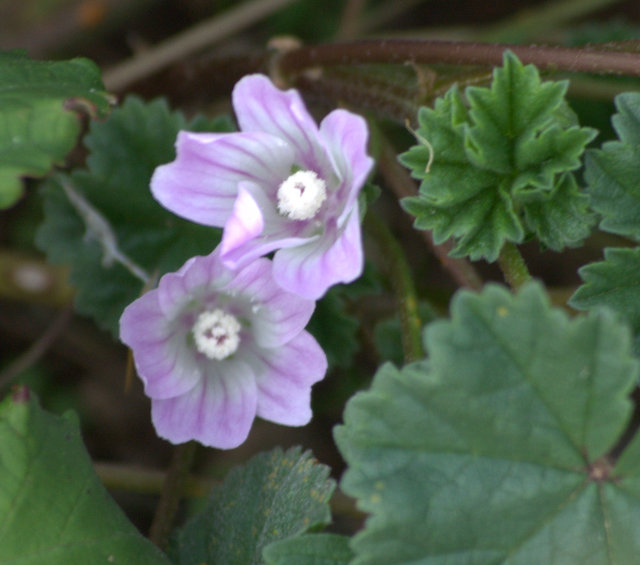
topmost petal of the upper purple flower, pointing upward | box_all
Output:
[232,74,328,172]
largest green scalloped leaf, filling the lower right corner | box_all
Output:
[335,283,640,565]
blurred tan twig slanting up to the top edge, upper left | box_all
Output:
[102,0,295,91]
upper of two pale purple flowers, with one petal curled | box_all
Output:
[151,75,373,299]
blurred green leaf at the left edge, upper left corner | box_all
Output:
[0,50,109,208]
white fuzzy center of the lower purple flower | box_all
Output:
[191,308,242,361]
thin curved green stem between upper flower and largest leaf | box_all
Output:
[365,211,424,363]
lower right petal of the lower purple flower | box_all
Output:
[252,331,327,426]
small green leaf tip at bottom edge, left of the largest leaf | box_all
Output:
[264,534,354,565]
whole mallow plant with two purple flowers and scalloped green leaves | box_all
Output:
[6,29,640,565]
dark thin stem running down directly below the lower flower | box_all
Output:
[149,441,198,549]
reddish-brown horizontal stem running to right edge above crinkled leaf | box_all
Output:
[279,39,640,76]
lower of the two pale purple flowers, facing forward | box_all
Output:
[120,250,327,449]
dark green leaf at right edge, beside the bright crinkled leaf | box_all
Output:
[585,92,640,241]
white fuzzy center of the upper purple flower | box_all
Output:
[278,171,327,220]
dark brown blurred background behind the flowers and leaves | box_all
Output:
[0,0,640,532]
